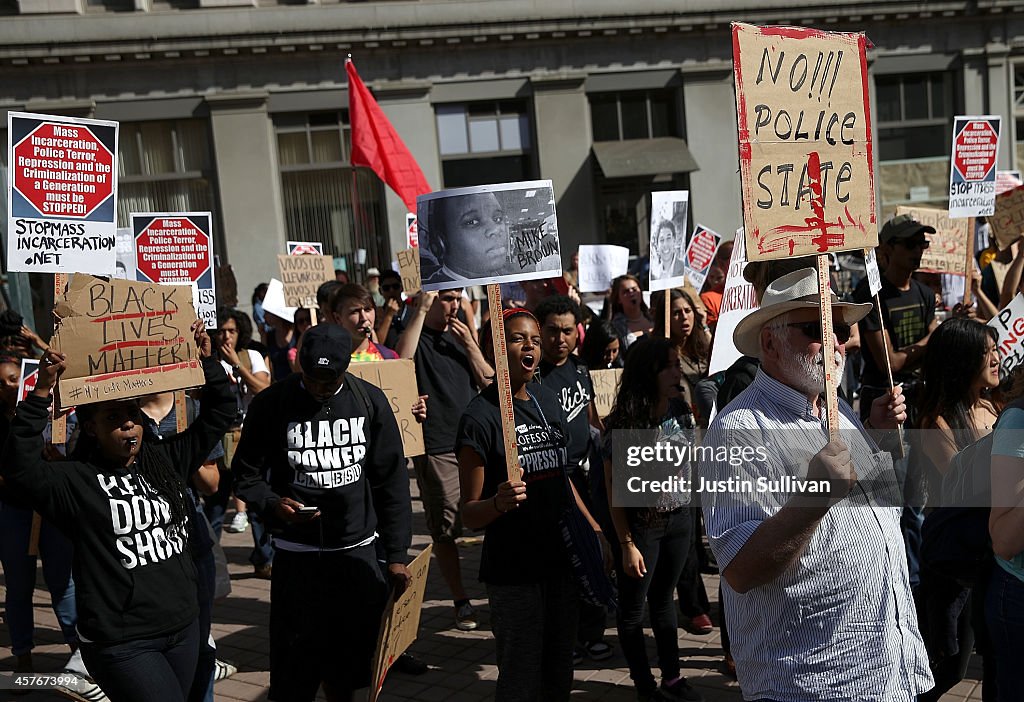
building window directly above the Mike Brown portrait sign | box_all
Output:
[435,100,535,187]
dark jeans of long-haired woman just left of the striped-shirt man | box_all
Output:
[616,508,693,692]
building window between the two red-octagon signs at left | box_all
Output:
[118,120,217,227]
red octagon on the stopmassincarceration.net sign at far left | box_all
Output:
[11,122,117,219]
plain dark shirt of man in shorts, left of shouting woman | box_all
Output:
[414,325,476,455]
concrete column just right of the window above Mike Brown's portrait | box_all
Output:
[530,75,603,267]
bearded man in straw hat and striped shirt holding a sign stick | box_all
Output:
[695,268,933,702]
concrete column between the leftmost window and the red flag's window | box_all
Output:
[206,91,286,304]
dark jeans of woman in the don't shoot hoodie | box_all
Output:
[82,620,200,702]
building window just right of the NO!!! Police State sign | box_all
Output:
[874,72,956,217]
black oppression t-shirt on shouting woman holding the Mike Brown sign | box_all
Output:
[456,384,571,585]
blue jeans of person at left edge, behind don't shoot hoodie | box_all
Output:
[0,504,78,656]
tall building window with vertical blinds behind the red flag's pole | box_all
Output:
[273,109,391,267]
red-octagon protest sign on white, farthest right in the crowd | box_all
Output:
[949,115,1001,218]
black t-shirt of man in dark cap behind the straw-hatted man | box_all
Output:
[853,275,935,387]
